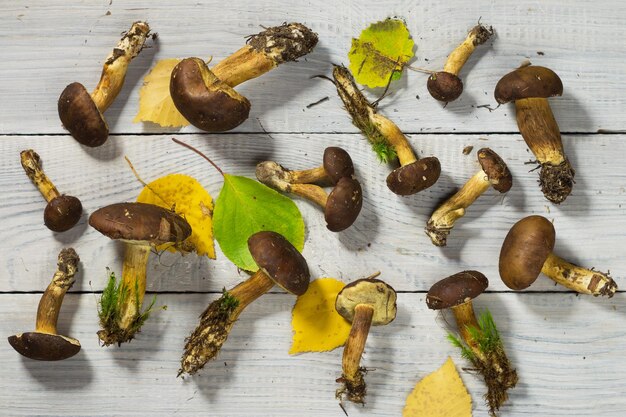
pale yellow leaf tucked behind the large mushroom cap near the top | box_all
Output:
[133,58,189,127]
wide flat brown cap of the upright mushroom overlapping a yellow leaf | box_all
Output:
[89,203,191,245]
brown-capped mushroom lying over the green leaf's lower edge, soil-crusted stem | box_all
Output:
[178,231,310,376]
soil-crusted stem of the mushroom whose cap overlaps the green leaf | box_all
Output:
[178,270,274,376]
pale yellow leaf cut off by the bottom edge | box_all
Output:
[402,357,472,417]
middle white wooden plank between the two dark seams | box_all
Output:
[0,134,626,291]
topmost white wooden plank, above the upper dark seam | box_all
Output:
[0,0,626,134]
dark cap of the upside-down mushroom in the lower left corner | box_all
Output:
[8,332,80,361]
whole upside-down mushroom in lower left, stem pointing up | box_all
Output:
[8,248,80,361]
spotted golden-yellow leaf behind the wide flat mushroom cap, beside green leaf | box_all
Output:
[137,174,215,259]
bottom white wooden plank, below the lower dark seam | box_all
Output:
[0,294,626,417]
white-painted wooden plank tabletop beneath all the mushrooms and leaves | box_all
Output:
[0,0,626,416]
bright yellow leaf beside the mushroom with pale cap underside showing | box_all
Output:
[289,278,350,355]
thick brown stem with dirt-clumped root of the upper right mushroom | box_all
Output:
[515,97,574,204]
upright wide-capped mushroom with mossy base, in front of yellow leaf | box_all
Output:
[89,203,191,346]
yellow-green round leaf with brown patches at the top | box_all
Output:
[348,18,415,88]
